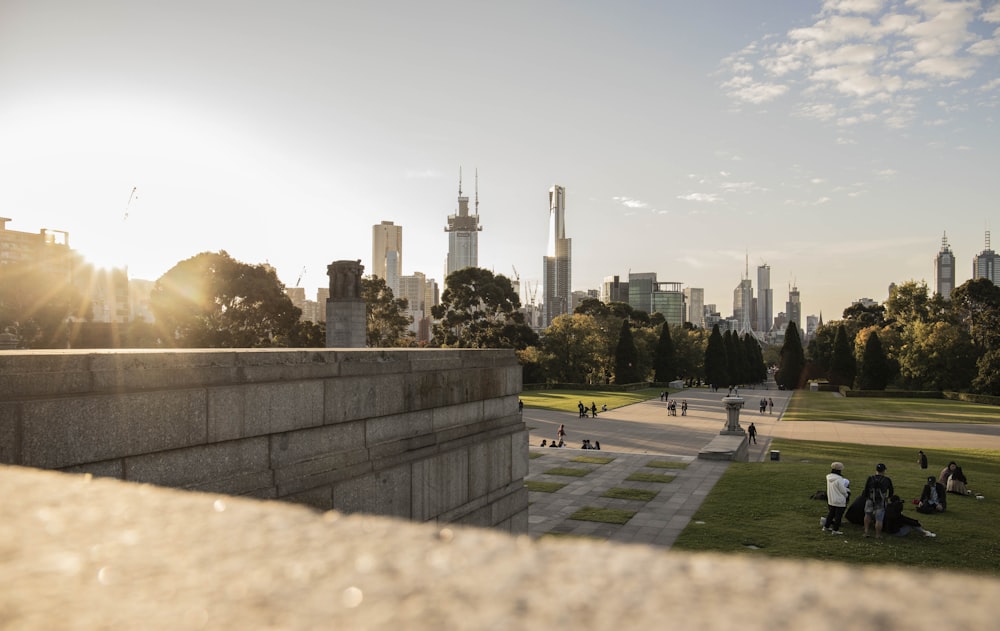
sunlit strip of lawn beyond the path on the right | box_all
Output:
[781,390,1000,425]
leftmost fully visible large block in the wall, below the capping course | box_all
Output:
[21,390,206,469]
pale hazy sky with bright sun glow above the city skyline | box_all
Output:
[0,0,1000,321]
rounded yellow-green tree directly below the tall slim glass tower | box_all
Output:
[539,313,604,383]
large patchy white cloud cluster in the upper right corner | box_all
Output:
[720,0,1000,128]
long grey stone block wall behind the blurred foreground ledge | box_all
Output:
[0,349,528,532]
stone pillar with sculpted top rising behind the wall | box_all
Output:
[326,260,368,348]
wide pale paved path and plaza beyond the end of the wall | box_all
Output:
[524,387,1000,547]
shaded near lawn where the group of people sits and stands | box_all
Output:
[673,439,1000,576]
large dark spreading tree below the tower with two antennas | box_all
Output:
[431,267,538,350]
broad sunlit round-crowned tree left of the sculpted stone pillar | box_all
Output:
[150,251,302,348]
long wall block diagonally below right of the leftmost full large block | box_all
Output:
[125,437,269,488]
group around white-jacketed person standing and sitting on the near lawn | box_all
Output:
[820,462,944,539]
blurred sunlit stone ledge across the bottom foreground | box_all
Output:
[0,467,1000,631]
